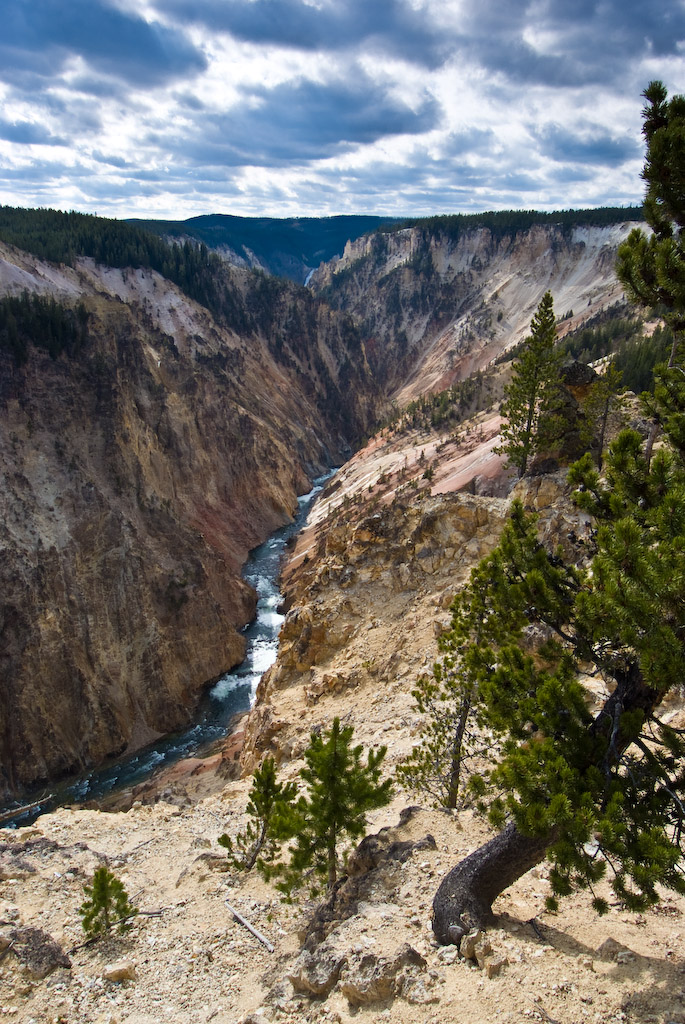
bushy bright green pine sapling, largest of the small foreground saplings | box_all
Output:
[272,718,392,892]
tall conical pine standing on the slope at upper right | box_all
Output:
[497,292,560,476]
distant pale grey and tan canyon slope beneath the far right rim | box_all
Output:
[309,211,634,407]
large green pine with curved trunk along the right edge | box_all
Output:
[433,83,685,942]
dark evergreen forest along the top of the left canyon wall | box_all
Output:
[0,207,368,387]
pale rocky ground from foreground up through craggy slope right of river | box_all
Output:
[0,454,685,1024]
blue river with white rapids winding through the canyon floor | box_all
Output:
[3,471,327,827]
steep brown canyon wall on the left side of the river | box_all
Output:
[0,246,374,795]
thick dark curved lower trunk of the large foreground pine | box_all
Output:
[433,824,556,945]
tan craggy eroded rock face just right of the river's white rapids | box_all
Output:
[241,470,593,775]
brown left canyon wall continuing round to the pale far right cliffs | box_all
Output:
[0,211,643,798]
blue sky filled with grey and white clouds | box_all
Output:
[0,0,685,219]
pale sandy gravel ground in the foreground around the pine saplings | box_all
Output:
[0,741,685,1024]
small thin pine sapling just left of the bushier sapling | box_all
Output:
[218,758,297,871]
